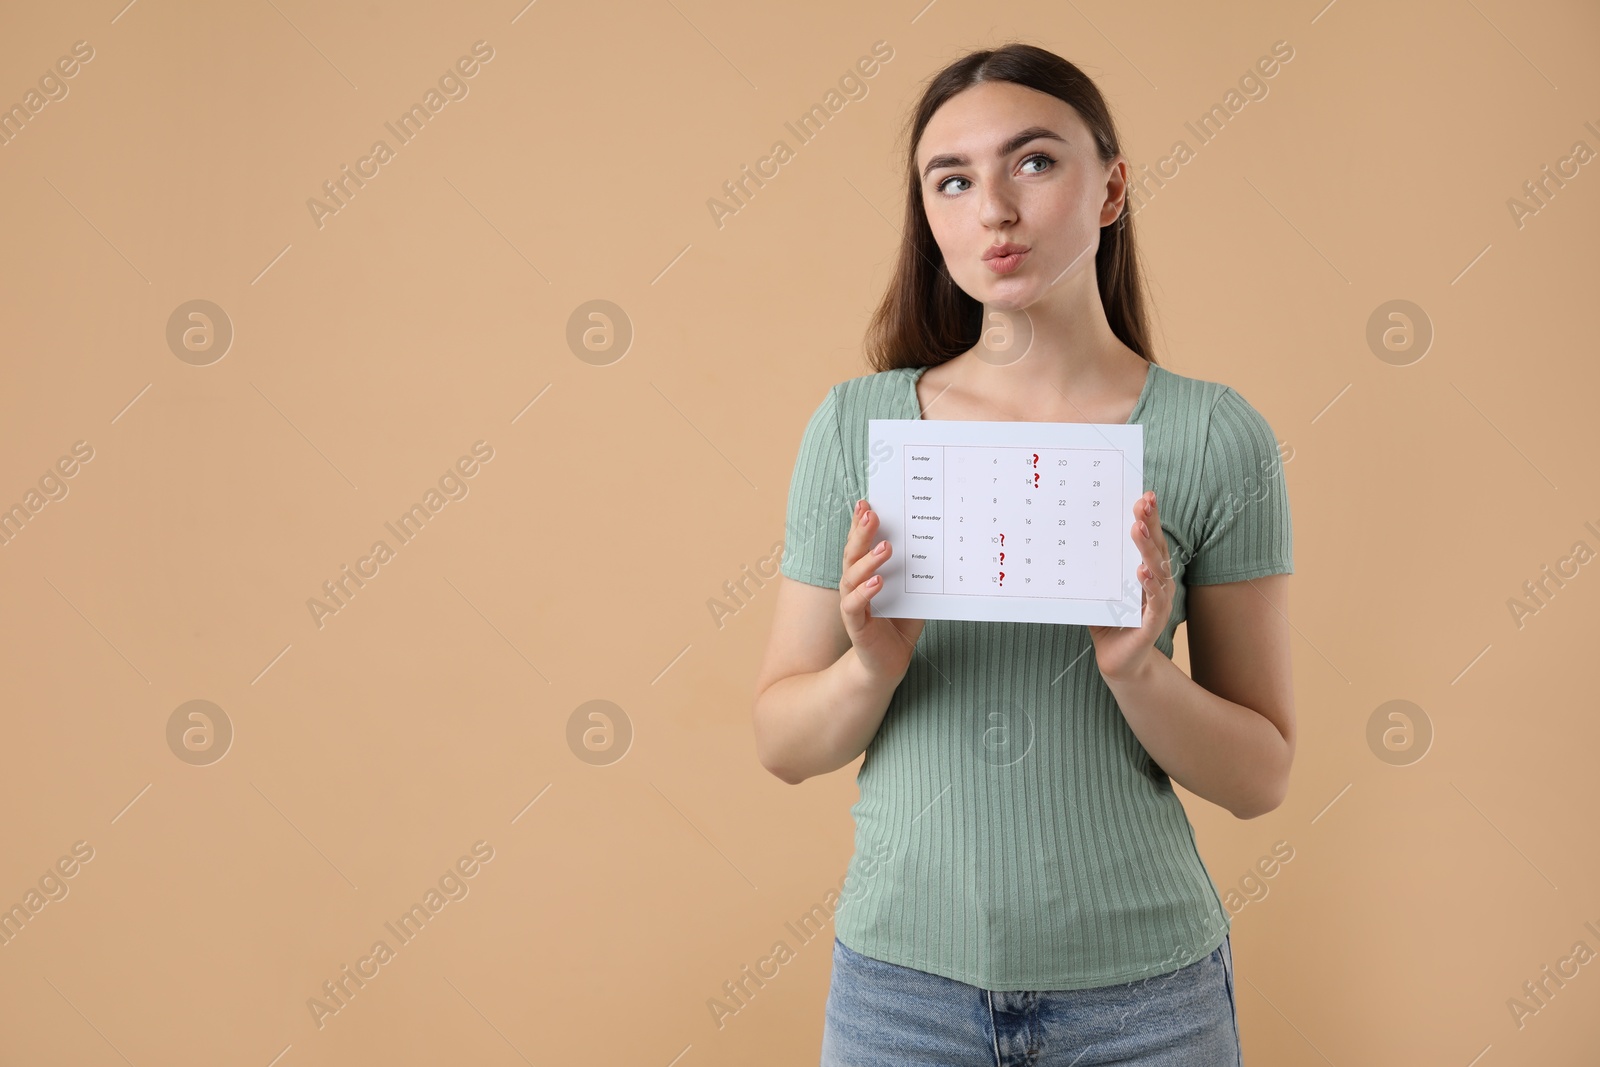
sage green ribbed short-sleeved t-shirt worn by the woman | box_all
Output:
[781,363,1294,990]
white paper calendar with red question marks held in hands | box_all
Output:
[867,419,1144,625]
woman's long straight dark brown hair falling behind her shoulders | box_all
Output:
[866,43,1157,371]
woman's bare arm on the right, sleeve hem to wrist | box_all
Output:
[1106,575,1294,819]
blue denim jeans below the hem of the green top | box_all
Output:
[822,937,1243,1067]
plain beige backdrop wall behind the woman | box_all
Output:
[0,0,1600,1067]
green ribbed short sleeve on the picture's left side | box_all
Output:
[778,386,856,589]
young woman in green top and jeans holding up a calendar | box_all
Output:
[755,45,1294,1067]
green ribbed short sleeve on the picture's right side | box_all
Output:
[1184,387,1294,585]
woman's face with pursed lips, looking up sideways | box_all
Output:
[915,82,1126,310]
